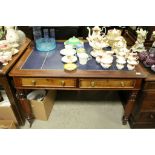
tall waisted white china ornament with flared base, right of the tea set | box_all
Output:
[131,28,148,52]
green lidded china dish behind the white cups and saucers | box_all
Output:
[64,36,84,48]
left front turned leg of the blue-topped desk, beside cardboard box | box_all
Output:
[17,90,34,127]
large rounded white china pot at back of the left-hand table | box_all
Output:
[5,26,19,43]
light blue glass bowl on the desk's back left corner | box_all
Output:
[36,38,56,52]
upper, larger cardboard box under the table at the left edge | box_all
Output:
[0,91,18,123]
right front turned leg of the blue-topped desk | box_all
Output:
[122,90,138,125]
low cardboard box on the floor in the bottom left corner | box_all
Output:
[0,120,16,129]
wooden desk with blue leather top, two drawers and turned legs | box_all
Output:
[9,42,145,125]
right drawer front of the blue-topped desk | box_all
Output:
[79,79,136,88]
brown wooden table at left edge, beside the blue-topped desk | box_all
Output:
[0,38,31,125]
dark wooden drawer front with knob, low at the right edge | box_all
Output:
[138,112,155,122]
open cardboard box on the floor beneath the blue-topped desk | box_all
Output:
[30,90,56,121]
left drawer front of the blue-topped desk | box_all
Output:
[20,78,76,88]
